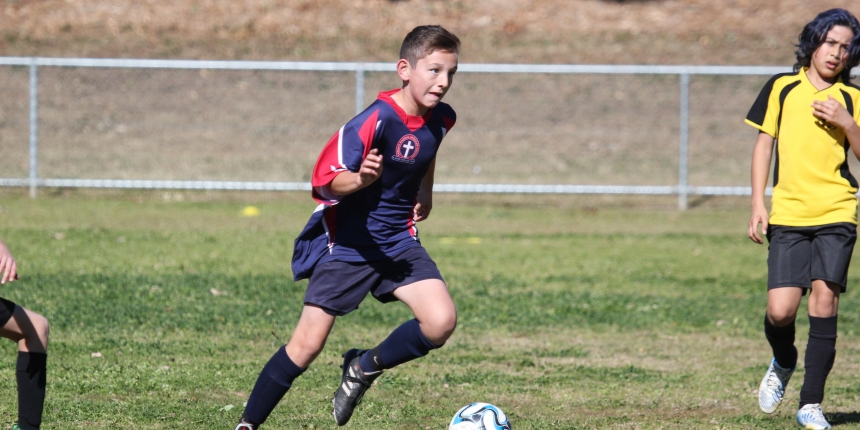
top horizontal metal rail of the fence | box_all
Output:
[0,57,848,75]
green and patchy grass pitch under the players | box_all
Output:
[0,190,860,429]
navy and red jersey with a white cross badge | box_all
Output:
[292,89,456,280]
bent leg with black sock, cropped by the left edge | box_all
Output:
[0,306,50,430]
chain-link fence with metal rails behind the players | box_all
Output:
[0,58,860,209]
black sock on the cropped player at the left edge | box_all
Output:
[15,351,48,430]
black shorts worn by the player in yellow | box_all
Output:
[767,223,857,294]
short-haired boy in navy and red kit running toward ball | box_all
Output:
[236,26,460,430]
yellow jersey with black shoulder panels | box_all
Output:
[746,69,860,227]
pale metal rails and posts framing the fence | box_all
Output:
[5,57,860,205]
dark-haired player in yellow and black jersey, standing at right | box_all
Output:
[746,9,860,429]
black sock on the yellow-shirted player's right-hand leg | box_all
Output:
[800,316,838,407]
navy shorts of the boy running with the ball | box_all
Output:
[305,246,444,316]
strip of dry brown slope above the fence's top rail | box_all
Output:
[0,0,858,65]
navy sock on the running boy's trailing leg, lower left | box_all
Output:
[242,346,305,425]
